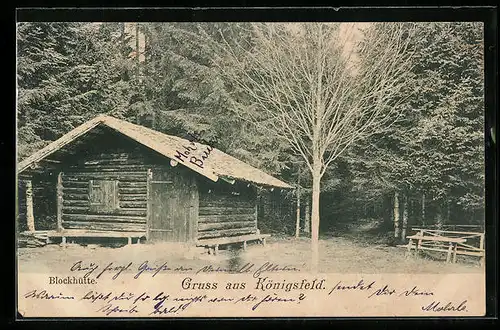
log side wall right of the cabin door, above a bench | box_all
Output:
[198,183,257,239]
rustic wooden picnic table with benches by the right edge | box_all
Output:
[406,228,484,264]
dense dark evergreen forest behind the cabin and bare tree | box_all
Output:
[17,22,484,240]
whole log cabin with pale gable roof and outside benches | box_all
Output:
[17,115,293,252]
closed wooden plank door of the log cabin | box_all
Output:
[148,170,187,242]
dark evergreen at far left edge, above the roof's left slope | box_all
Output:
[17,23,78,157]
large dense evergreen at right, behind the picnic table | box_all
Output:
[348,23,484,228]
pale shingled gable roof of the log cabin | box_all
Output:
[18,115,293,188]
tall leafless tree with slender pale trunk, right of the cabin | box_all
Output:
[210,23,411,270]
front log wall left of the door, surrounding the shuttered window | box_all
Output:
[62,152,148,232]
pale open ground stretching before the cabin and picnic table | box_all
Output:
[18,223,484,274]
